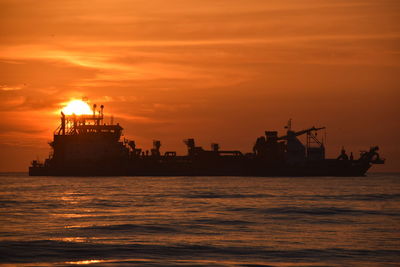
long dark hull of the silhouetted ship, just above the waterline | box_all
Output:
[29,159,371,177]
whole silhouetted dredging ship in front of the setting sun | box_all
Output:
[29,105,385,177]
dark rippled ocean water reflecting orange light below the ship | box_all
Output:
[0,174,400,266]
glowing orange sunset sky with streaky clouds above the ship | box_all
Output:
[0,0,400,171]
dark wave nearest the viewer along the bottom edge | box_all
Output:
[0,240,400,263]
